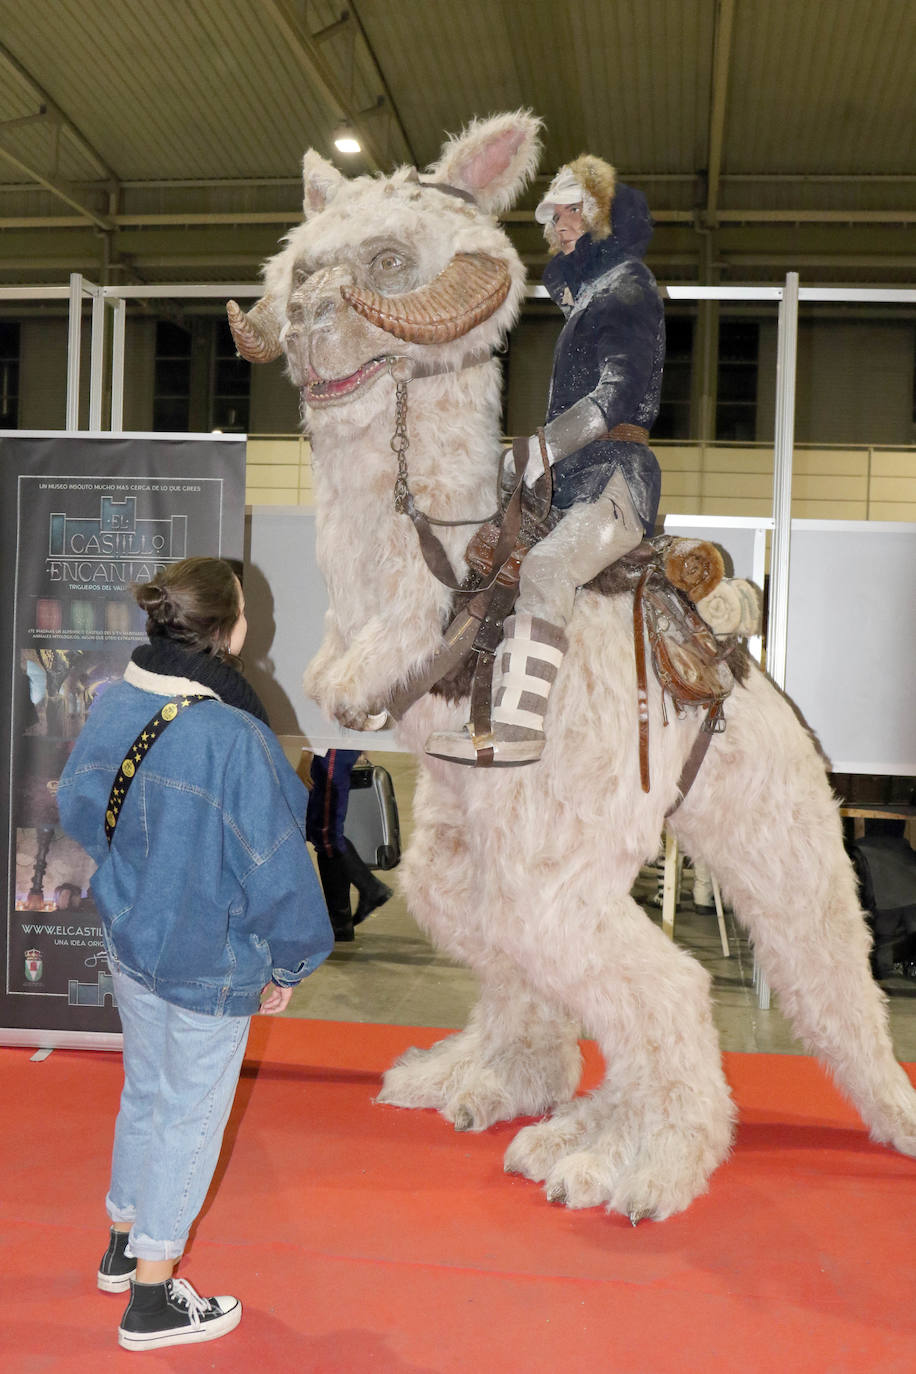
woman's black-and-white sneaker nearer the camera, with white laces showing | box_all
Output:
[118,1279,242,1351]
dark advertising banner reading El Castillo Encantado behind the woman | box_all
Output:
[0,431,244,1046]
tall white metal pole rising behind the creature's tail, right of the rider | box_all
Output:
[766,272,798,687]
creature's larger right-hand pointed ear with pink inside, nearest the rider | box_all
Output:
[430,110,541,214]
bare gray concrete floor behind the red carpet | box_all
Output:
[287,753,916,1062]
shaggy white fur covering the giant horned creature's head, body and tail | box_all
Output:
[238,111,916,1221]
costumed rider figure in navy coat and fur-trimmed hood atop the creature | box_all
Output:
[426,154,665,764]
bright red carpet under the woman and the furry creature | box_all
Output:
[0,1017,916,1374]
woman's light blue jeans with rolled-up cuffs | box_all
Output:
[106,970,251,1260]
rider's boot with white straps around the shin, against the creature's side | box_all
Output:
[426,611,567,765]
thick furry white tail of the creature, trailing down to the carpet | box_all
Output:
[672,673,916,1154]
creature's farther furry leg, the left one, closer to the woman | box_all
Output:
[376,774,581,1131]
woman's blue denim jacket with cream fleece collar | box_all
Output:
[58,664,334,1015]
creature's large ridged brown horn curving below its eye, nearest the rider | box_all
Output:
[341,253,511,344]
